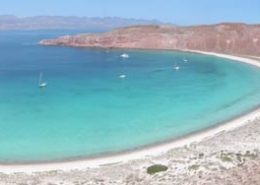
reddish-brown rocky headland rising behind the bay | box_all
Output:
[40,23,260,56]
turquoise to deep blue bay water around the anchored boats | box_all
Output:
[0,31,260,163]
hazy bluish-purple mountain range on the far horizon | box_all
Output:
[0,15,169,30]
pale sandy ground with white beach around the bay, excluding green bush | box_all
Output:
[0,50,260,185]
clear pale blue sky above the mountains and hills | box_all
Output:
[0,0,260,25]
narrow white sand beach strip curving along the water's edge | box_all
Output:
[0,50,260,173]
